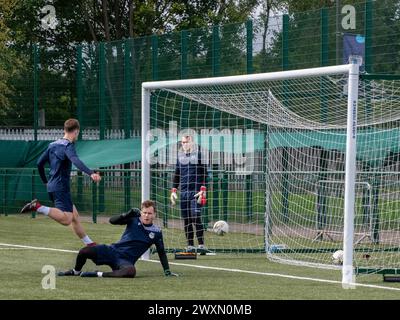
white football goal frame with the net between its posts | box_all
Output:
[142,60,359,288]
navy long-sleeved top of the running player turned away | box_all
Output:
[37,138,93,192]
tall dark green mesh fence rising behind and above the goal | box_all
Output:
[0,0,400,132]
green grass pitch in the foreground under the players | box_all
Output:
[0,216,400,300]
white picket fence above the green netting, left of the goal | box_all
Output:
[0,128,140,141]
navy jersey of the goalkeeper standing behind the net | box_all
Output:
[173,151,208,192]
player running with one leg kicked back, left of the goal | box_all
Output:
[21,119,101,246]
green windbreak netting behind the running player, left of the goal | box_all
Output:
[0,138,141,203]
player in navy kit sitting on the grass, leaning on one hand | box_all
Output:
[58,200,177,278]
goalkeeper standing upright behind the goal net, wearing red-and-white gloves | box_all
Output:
[171,135,208,251]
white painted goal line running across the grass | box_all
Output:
[0,243,400,291]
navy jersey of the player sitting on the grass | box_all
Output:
[111,217,165,264]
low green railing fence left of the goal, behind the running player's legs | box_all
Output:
[0,168,141,222]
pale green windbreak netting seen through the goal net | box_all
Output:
[150,128,400,167]
